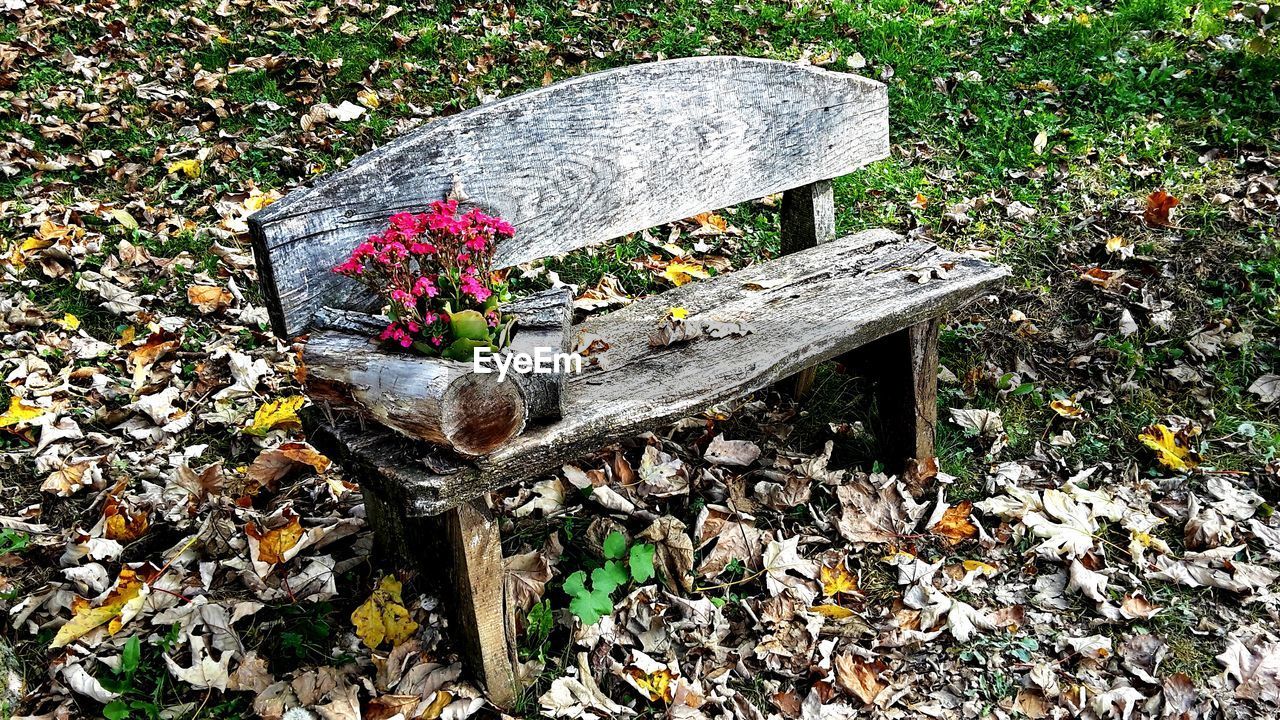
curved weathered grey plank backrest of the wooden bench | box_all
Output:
[250,56,888,337]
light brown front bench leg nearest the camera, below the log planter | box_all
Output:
[440,498,520,710]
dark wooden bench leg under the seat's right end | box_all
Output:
[859,319,938,474]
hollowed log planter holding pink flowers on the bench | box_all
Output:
[302,331,529,455]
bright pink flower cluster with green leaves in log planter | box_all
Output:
[333,200,516,360]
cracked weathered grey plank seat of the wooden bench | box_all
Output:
[307,231,1007,515]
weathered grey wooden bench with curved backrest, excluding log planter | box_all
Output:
[250,58,1005,707]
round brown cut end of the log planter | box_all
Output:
[440,373,527,455]
